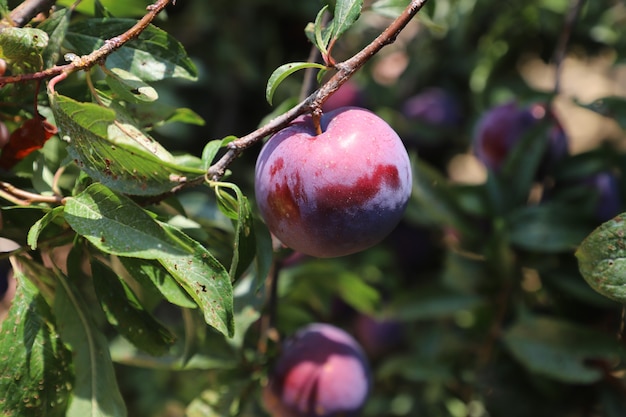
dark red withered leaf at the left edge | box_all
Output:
[0,115,57,169]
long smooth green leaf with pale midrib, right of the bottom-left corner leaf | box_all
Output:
[54,262,126,417]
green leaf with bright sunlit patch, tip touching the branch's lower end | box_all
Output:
[51,95,204,195]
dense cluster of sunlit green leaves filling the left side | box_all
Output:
[0,1,272,416]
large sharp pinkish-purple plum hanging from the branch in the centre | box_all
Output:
[255,107,412,258]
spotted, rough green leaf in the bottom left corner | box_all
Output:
[0,262,73,417]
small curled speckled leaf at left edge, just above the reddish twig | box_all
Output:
[0,27,49,72]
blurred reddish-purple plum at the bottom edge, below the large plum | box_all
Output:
[263,323,371,417]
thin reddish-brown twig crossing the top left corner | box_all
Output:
[0,0,172,87]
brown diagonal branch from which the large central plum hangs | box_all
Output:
[207,0,427,181]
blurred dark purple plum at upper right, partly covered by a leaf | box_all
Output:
[473,102,568,175]
